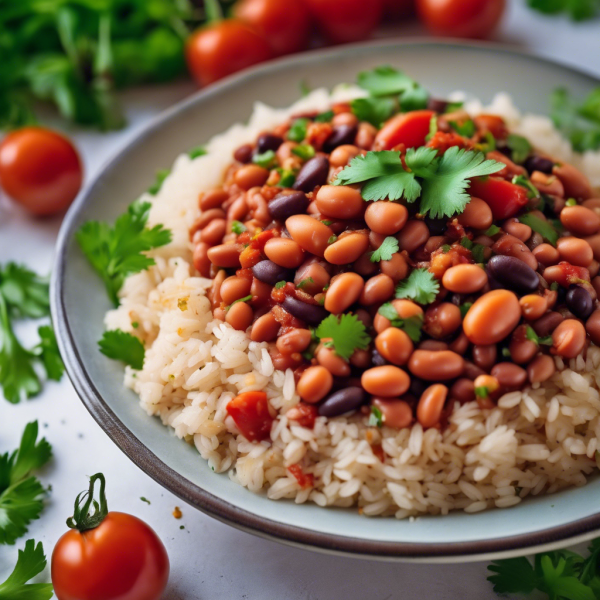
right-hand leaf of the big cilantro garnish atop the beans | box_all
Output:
[420,146,506,219]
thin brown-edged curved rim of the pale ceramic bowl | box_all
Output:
[50,38,600,562]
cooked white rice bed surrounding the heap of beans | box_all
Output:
[106,87,600,518]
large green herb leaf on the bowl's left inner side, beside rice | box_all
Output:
[76,202,171,306]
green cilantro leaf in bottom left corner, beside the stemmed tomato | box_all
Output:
[0,540,53,600]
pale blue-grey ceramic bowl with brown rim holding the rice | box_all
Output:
[52,41,600,561]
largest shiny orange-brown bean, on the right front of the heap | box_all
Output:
[463,290,521,346]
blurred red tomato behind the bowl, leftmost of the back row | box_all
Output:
[185,19,273,85]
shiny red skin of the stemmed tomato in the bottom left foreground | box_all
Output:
[52,512,169,600]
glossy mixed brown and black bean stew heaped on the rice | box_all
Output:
[190,101,600,439]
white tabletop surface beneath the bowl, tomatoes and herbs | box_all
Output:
[0,0,600,600]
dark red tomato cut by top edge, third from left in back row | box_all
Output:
[305,0,383,44]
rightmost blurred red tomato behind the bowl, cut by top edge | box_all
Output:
[417,0,506,38]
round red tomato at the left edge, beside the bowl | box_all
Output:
[0,127,83,216]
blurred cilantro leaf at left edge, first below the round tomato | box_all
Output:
[0,262,50,319]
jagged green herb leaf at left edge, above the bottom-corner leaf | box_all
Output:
[0,421,52,544]
